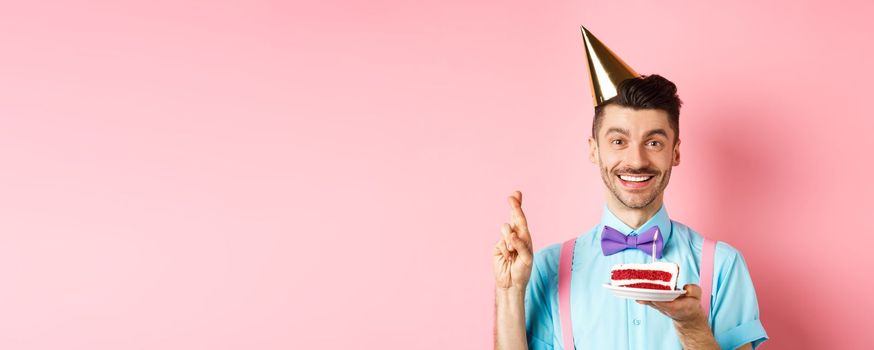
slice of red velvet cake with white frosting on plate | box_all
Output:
[610,261,680,290]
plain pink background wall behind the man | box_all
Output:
[0,0,874,349]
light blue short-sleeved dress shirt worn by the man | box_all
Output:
[525,206,768,350]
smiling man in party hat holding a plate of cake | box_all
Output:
[494,29,768,349]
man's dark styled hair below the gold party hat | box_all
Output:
[592,74,683,141]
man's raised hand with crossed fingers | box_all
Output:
[494,191,534,291]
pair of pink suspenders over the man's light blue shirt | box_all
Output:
[558,238,716,350]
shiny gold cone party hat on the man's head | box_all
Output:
[580,26,640,106]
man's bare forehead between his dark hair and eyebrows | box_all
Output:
[598,105,674,137]
